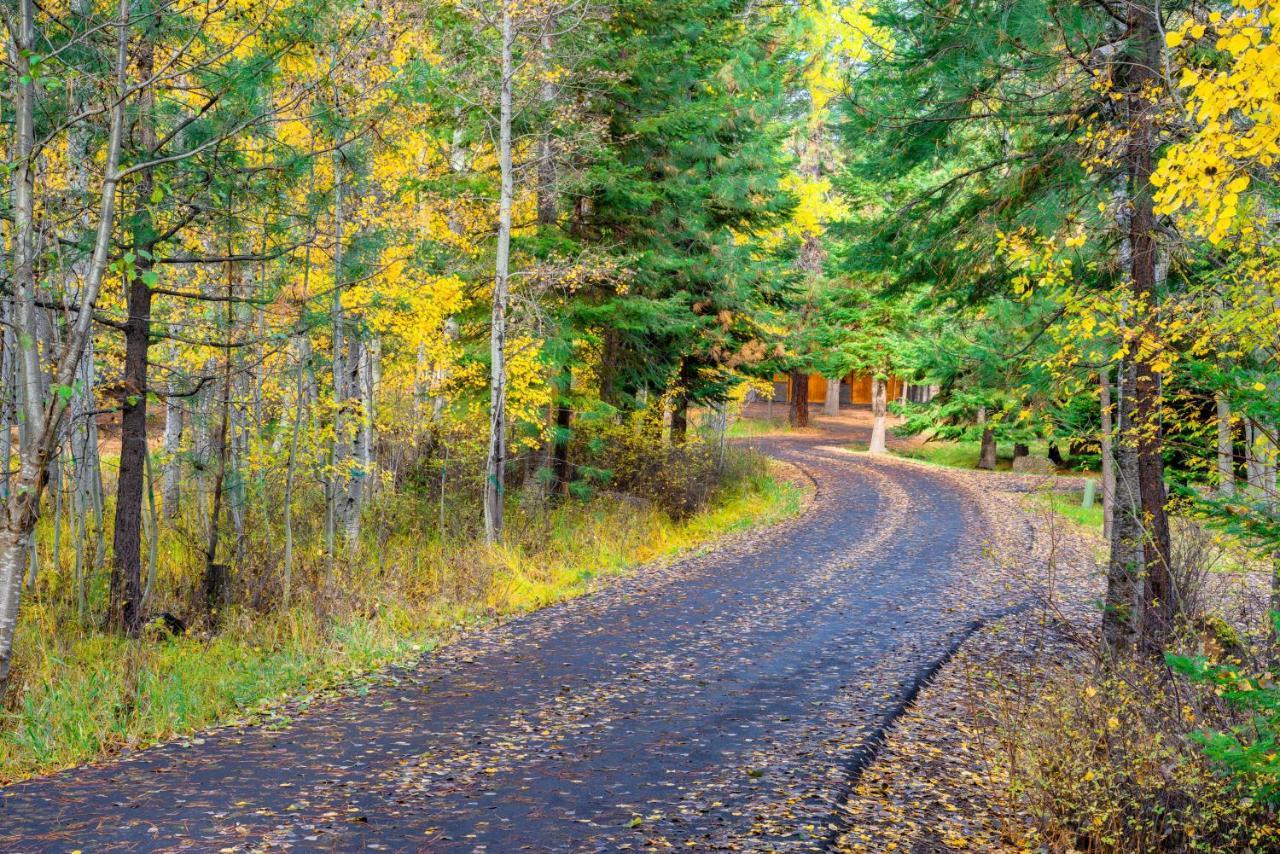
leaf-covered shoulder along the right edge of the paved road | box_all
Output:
[833,461,1102,851]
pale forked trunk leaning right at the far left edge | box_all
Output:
[0,0,129,697]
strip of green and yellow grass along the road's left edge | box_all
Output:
[0,470,804,784]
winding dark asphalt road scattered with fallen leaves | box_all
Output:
[0,425,1034,853]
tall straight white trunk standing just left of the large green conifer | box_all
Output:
[484,0,515,544]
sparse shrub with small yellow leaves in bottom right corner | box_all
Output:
[998,662,1280,851]
